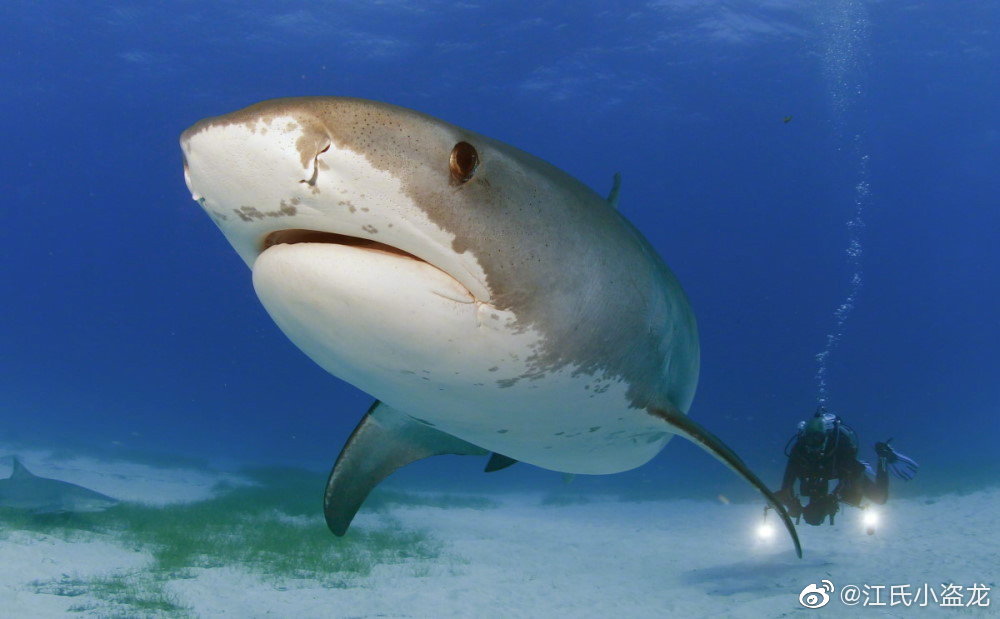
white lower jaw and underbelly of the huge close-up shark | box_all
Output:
[253,244,672,474]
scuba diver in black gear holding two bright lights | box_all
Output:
[776,406,918,525]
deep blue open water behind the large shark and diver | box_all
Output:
[0,0,1000,508]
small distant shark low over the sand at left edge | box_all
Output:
[0,457,118,515]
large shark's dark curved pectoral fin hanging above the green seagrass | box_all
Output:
[323,400,488,536]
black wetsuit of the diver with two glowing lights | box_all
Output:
[778,423,889,524]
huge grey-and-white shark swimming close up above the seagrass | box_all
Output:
[180,97,801,556]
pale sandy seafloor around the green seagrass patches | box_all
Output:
[0,450,1000,617]
